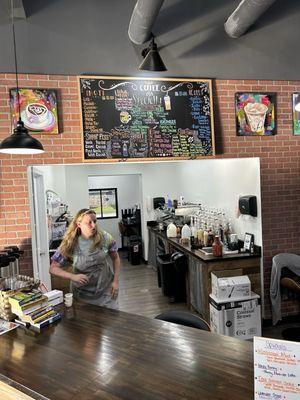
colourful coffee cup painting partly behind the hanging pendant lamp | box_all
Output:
[10,88,59,134]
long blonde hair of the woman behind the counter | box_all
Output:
[59,208,102,261]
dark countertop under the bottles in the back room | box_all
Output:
[148,226,261,262]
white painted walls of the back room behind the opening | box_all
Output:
[39,158,262,259]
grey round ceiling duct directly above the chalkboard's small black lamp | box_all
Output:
[128,0,164,44]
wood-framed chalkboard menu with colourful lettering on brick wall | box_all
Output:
[79,76,214,162]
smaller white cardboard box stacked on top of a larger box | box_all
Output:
[211,269,251,301]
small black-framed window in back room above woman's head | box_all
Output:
[89,188,118,219]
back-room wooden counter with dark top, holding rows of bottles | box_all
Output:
[148,227,261,321]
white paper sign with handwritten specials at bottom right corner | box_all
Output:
[254,337,300,400]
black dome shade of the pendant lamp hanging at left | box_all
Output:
[0,119,44,154]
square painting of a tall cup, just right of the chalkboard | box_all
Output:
[235,93,276,136]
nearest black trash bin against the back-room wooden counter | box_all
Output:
[157,252,187,302]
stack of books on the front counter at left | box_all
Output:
[9,290,61,330]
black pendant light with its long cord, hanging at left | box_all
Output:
[0,0,44,154]
